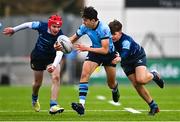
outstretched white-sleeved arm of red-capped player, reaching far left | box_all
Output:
[3,22,33,36]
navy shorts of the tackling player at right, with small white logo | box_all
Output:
[121,55,146,76]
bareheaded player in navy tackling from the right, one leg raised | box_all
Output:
[109,20,164,115]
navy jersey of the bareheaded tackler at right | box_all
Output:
[114,33,145,64]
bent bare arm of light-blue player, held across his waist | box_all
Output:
[75,39,109,54]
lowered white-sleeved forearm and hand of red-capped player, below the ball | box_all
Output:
[47,51,63,73]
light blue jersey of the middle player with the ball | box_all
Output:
[76,21,115,53]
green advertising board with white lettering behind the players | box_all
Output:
[91,58,180,84]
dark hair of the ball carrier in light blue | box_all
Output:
[82,6,98,21]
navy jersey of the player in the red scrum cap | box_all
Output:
[32,21,63,58]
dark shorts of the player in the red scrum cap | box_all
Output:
[30,52,56,71]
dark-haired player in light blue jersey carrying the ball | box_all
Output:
[55,7,119,115]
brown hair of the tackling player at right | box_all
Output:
[109,20,122,34]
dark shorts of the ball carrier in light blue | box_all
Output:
[86,52,116,67]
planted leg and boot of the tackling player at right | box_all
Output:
[128,73,159,115]
